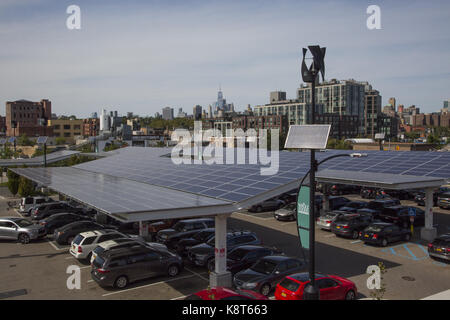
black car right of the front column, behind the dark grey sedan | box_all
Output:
[221,245,282,274]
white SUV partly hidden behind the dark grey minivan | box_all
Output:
[69,229,126,261]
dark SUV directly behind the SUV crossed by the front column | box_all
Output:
[156,218,214,248]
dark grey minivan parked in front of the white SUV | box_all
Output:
[91,247,183,289]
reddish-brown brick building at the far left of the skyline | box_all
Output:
[6,99,52,137]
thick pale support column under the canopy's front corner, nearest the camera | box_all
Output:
[209,214,232,287]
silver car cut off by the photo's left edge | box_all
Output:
[0,217,45,244]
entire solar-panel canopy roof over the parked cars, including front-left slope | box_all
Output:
[10,147,450,221]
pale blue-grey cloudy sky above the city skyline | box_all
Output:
[0,0,450,117]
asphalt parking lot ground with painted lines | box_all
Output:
[0,190,450,300]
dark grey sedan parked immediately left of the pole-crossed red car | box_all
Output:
[233,256,307,296]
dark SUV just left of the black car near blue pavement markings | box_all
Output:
[331,214,373,239]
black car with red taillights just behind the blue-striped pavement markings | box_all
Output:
[360,222,411,247]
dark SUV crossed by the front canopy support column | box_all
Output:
[188,231,261,271]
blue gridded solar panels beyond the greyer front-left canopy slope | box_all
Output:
[75,148,450,202]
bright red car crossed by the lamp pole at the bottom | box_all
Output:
[275,272,358,300]
